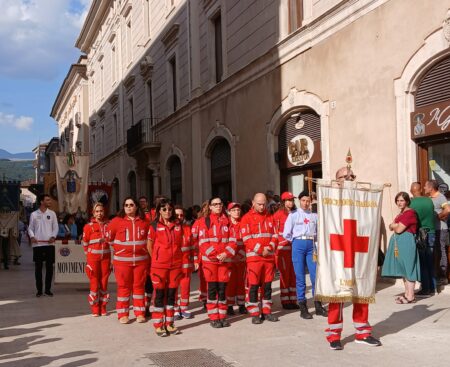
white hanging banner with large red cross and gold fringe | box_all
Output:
[316,180,383,303]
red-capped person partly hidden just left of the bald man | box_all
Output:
[227,203,248,316]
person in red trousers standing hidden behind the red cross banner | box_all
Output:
[325,167,381,350]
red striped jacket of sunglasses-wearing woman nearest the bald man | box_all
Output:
[194,214,236,263]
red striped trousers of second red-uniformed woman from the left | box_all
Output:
[114,261,149,319]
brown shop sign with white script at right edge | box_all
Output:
[411,101,450,139]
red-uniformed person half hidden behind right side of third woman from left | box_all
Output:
[175,206,198,319]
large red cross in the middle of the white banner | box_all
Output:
[330,219,369,268]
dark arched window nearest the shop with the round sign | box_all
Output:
[211,138,232,201]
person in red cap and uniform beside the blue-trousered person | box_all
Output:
[273,192,299,310]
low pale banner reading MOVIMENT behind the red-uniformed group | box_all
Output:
[55,241,116,284]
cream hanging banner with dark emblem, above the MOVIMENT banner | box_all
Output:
[55,152,89,214]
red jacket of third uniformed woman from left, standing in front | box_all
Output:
[148,221,184,269]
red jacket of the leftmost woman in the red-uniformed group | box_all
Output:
[83,218,111,261]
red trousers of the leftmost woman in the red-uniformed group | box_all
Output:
[86,257,111,315]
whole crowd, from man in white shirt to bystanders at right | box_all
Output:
[28,167,450,350]
